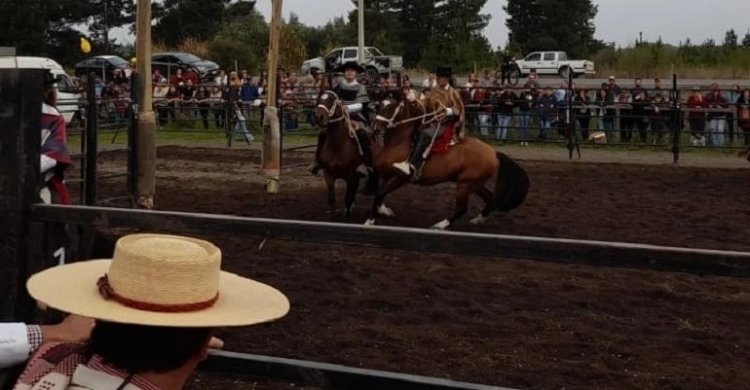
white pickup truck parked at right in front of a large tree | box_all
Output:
[516,51,596,79]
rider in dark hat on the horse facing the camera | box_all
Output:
[310,61,372,176]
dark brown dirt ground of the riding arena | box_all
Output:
[86,147,750,389]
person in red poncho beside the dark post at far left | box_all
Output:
[39,71,72,204]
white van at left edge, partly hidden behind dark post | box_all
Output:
[0,56,81,123]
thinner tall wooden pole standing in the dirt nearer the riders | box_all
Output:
[263,0,282,194]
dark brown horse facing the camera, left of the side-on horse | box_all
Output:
[315,91,377,217]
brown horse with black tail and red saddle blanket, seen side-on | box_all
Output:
[365,92,529,230]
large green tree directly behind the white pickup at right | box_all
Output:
[503,0,604,57]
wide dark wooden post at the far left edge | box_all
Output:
[0,69,43,321]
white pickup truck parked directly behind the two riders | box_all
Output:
[302,46,404,81]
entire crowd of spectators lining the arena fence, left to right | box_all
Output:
[70,69,750,146]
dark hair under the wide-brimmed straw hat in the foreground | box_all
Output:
[89,321,213,374]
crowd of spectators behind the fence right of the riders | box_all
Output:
[456,72,750,146]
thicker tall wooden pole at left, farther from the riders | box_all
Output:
[135,0,156,209]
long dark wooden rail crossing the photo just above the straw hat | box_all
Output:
[32,205,750,278]
